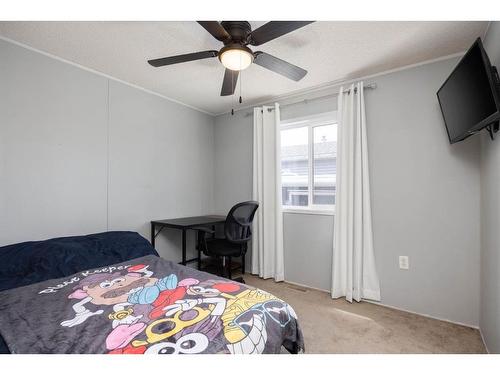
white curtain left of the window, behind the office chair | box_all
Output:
[252,104,285,281]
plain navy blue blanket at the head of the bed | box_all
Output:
[0,232,158,354]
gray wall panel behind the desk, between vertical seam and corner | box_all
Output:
[109,81,214,260]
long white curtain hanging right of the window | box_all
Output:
[332,82,380,302]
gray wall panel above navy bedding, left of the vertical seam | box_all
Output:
[0,40,107,245]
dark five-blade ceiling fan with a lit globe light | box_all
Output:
[148,21,314,96]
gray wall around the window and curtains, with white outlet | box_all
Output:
[215,55,480,326]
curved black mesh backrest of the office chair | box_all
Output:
[224,201,259,243]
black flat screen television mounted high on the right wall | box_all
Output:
[437,38,500,143]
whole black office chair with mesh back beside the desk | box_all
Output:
[193,201,259,283]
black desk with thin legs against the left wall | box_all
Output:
[151,215,226,269]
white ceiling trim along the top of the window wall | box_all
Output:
[215,51,466,116]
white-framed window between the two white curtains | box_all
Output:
[281,113,337,210]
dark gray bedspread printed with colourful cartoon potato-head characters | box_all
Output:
[0,255,303,354]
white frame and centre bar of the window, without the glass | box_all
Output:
[280,111,338,215]
